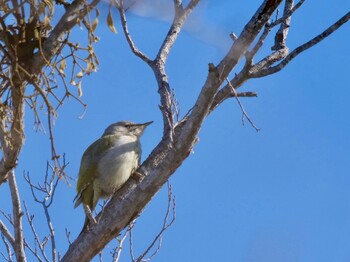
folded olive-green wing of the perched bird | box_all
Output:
[75,136,114,206]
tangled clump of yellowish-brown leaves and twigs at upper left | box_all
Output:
[0,0,99,183]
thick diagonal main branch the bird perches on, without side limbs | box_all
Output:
[62,0,281,261]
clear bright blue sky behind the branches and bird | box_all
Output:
[0,0,350,262]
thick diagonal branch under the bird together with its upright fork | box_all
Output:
[62,0,348,261]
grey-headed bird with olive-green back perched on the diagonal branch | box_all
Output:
[74,121,153,231]
